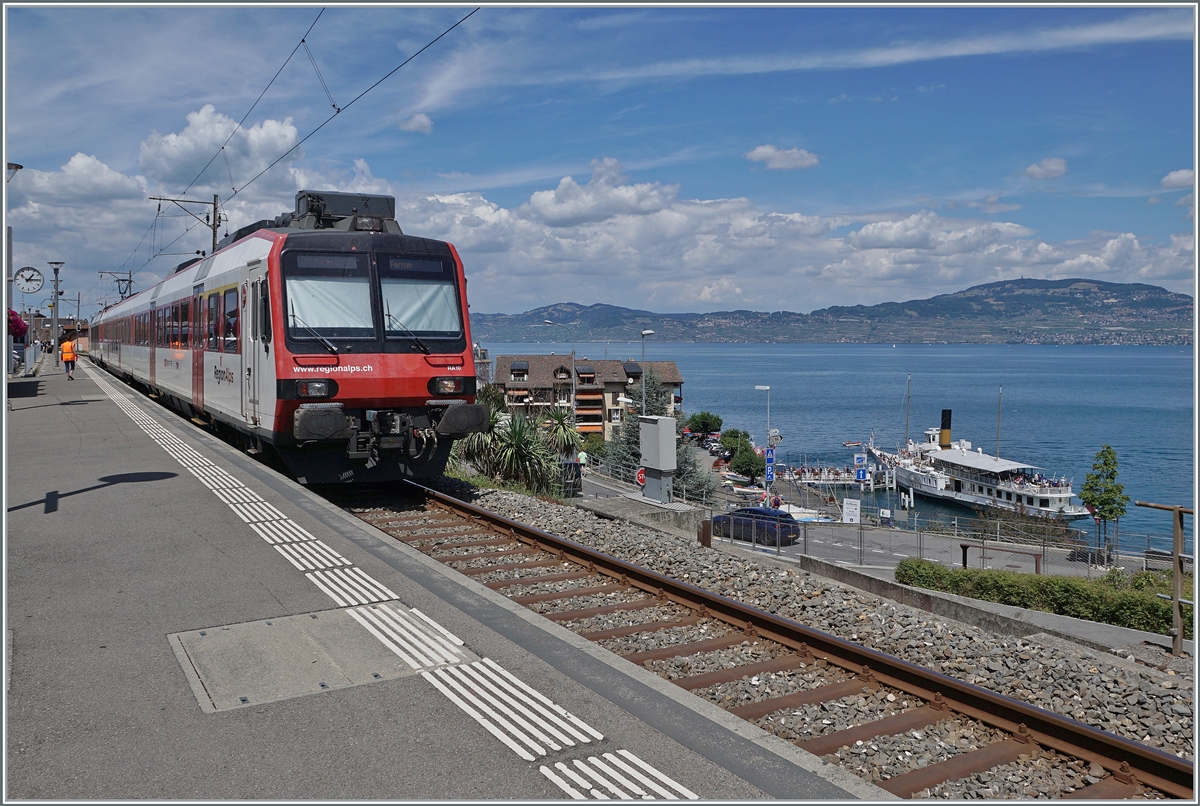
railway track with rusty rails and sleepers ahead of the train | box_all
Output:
[330,486,1193,800]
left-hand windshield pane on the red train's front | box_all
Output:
[284,253,376,339]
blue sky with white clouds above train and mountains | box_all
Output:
[4,5,1196,314]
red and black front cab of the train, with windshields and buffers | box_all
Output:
[264,231,487,485]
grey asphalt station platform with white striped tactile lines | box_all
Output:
[5,359,893,801]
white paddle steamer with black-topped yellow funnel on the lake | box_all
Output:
[866,409,1091,521]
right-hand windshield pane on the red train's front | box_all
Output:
[378,255,462,338]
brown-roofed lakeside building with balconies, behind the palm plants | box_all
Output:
[493,355,683,439]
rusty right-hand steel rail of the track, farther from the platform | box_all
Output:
[409,482,1194,800]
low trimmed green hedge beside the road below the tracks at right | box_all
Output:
[896,558,1193,638]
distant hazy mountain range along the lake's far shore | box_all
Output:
[470,279,1194,344]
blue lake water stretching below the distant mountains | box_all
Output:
[484,341,1195,545]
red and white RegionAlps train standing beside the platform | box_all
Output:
[90,191,487,485]
